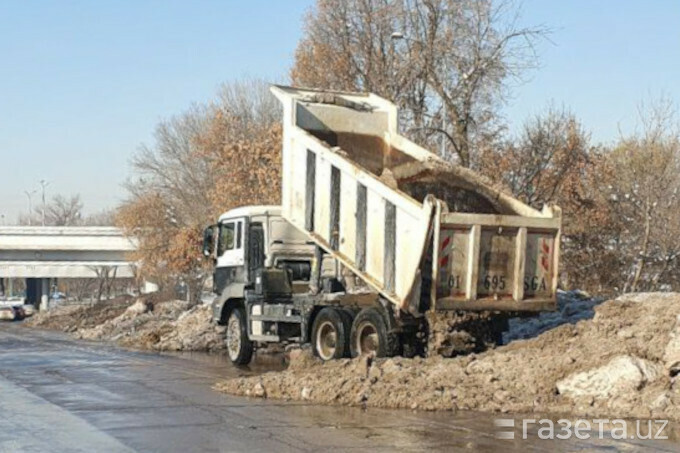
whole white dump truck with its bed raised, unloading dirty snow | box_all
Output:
[203,86,561,364]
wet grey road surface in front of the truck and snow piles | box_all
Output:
[0,324,680,453]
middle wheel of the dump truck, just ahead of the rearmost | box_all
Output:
[312,307,352,360]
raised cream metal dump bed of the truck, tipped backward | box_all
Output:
[272,86,561,313]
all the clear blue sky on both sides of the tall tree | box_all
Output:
[0,0,680,223]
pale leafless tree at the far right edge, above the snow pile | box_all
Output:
[607,99,680,291]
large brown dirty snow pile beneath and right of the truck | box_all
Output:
[216,293,680,420]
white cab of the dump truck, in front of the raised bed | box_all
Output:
[203,206,315,362]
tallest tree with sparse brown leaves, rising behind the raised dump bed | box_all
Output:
[292,0,547,166]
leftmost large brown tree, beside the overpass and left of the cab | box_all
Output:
[121,101,215,304]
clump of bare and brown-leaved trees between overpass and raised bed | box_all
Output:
[117,79,281,302]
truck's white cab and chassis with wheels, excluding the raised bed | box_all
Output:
[203,206,396,365]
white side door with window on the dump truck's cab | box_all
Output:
[214,219,246,294]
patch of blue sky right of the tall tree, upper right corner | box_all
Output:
[505,0,680,143]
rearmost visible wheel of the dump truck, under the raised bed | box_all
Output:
[350,307,399,357]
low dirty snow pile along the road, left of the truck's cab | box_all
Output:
[28,298,224,351]
